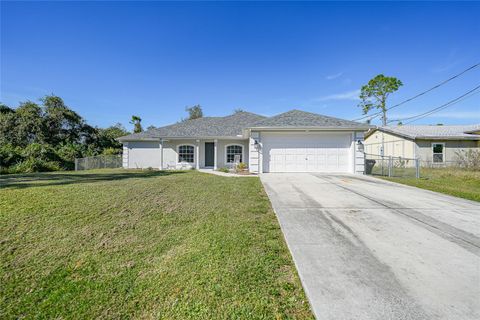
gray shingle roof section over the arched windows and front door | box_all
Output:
[118,111,265,141]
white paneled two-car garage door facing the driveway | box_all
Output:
[262,133,351,172]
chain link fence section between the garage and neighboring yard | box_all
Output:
[365,153,420,178]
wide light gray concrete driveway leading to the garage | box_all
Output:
[261,173,480,320]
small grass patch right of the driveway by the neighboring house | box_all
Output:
[382,168,480,201]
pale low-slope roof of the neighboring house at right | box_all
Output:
[372,124,480,140]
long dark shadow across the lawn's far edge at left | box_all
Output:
[0,171,185,189]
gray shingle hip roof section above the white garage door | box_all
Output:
[248,110,371,129]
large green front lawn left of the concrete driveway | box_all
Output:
[0,170,313,319]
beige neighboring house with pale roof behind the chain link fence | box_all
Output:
[365,124,480,165]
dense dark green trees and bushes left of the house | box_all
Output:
[0,95,129,173]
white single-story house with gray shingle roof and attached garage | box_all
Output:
[118,110,370,173]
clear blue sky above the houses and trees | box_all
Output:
[0,1,480,128]
